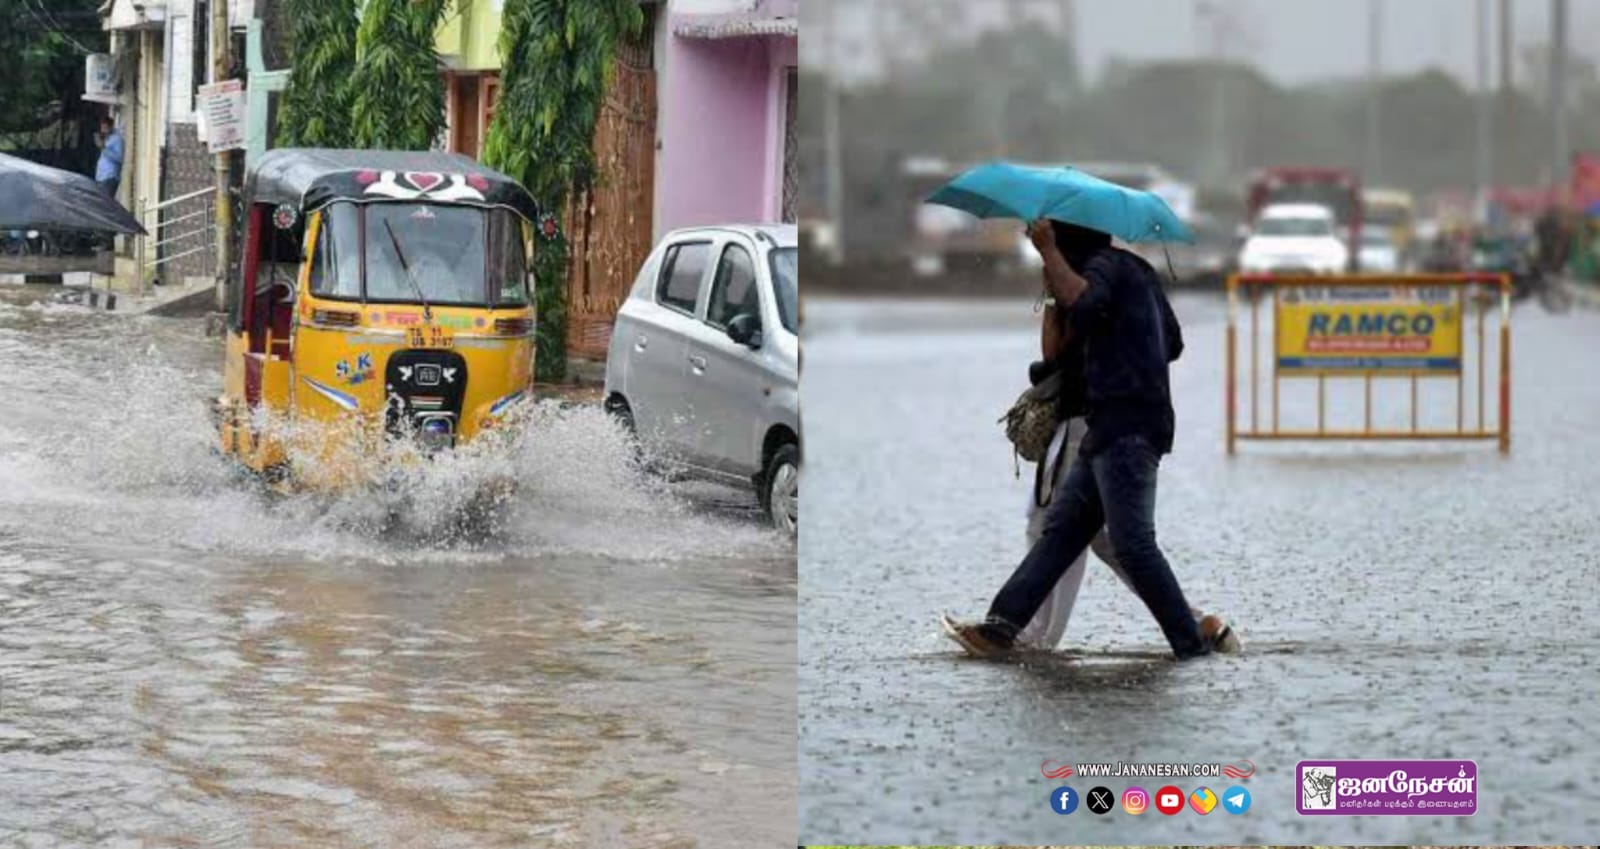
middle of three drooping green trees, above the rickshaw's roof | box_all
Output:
[348,0,448,150]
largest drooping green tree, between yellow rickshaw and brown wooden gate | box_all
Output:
[480,0,643,381]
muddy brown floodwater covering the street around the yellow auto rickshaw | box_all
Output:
[0,289,797,849]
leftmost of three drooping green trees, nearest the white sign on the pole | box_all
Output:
[277,0,358,147]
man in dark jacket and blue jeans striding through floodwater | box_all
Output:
[947,219,1238,660]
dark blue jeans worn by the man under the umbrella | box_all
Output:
[989,435,1211,660]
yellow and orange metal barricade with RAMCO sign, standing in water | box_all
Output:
[1226,273,1510,454]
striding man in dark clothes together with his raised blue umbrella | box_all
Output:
[931,163,1238,660]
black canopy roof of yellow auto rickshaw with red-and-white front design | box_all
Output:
[245,147,539,221]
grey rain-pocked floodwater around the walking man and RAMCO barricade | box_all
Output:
[800,294,1600,844]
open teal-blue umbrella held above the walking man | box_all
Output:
[928,161,1195,243]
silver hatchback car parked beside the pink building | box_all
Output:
[605,225,800,534]
